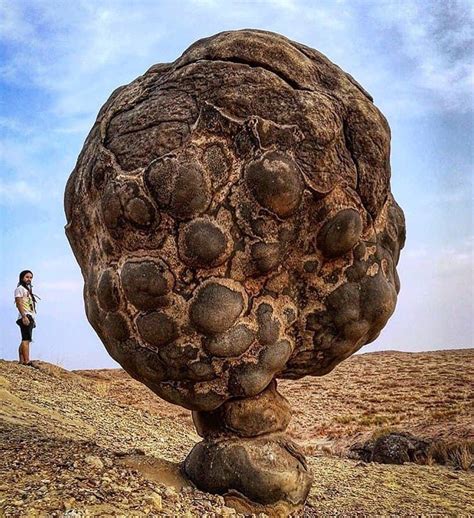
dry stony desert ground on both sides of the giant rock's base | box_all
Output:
[0,349,474,518]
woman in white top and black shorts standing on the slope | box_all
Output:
[15,270,37,365]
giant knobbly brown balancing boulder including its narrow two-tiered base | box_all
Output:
[65,30,405,512]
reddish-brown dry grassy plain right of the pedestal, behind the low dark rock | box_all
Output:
[279,349,474,456]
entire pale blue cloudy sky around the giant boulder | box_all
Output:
[0,0,474,368]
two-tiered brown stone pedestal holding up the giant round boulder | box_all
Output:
[184,381,311,515]
